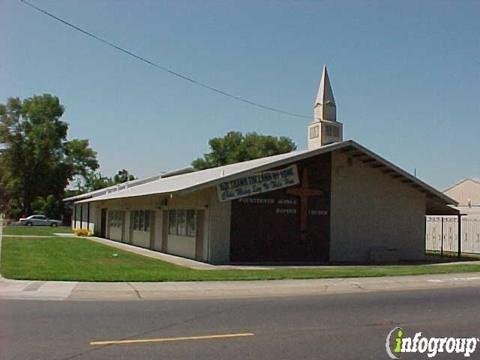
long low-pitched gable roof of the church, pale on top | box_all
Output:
[74,140,457,212]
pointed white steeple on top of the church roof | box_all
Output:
[308,66,343,150]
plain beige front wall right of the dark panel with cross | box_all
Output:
[330,153,426,262]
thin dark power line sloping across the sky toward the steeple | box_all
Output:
[20,0,310,119]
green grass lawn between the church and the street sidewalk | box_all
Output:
[0,237,480,281]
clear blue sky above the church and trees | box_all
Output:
[0,0,480,188]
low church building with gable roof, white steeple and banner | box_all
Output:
[65,68,457,264]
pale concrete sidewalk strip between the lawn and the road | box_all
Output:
[0,273,480,301]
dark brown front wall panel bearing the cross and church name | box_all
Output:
[230,154,331,263]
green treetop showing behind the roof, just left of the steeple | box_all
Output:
[192,131,297,170]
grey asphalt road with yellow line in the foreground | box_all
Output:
[0,287,480,360]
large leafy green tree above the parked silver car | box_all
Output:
[0,94,98,216]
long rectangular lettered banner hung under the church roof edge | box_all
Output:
[217,165,300,201]
